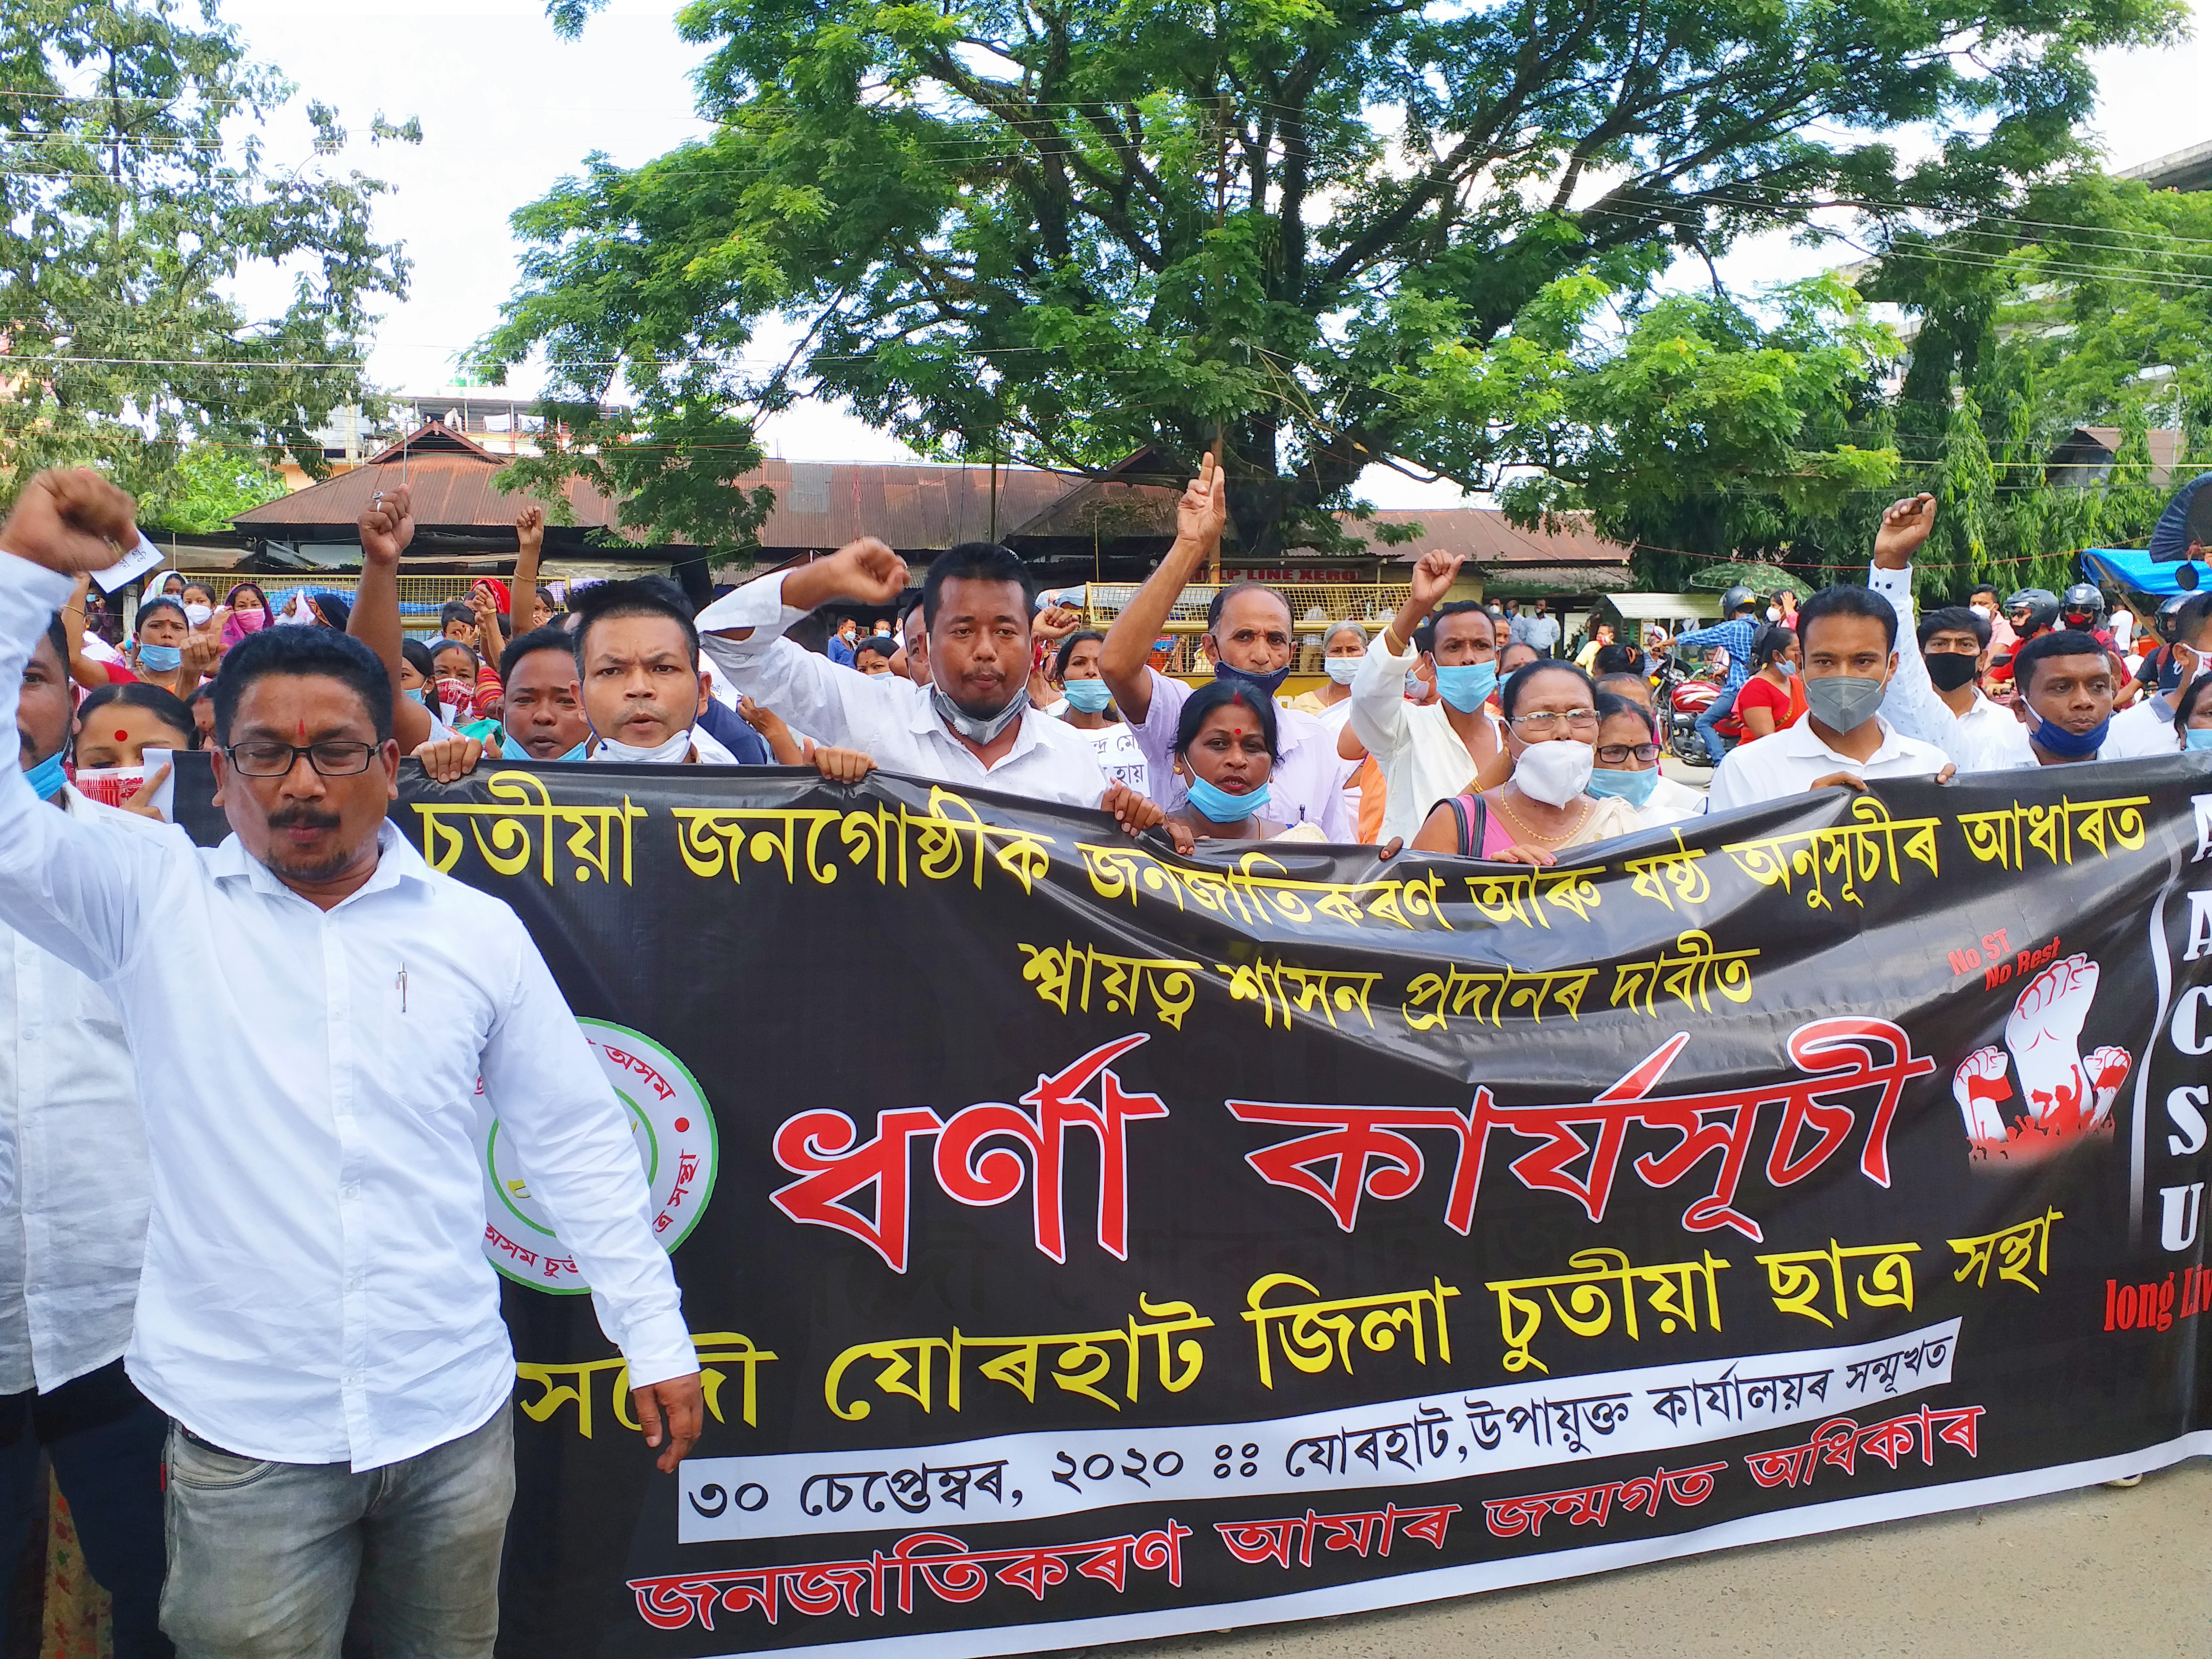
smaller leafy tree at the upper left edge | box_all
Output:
[0,0,421,520]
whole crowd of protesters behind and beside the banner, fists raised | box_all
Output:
[0,458,2212,1659]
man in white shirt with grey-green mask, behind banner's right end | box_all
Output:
[1707,589,1955,812]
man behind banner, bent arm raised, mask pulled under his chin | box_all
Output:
[699,535,1164,834]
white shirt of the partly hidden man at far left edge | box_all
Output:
[0,787,161,1394]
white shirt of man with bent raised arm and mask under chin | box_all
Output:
[699,575,1106,807]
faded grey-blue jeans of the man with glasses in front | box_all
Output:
[161,1405,516,1659]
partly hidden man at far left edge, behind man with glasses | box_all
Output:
[0,622,172,1659]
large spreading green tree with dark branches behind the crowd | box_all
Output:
[482,0,2181,553]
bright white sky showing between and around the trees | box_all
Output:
[223,0,2212,506]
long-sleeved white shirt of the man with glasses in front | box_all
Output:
[0,553,690,1469]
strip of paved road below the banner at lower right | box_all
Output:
[1093,1458,2212,1659]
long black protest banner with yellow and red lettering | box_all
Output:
[179,757,2212,1659]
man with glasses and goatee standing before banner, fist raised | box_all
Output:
[0,471,701,1659]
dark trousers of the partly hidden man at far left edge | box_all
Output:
[0,1360,175,1659]
